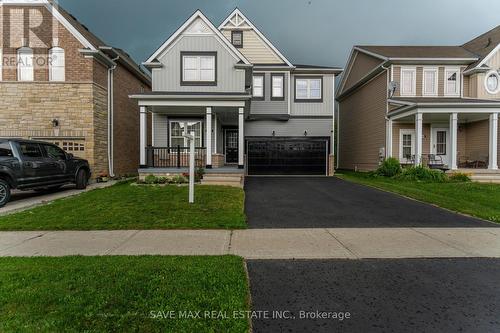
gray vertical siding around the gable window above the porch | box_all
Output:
[153,35,245,92]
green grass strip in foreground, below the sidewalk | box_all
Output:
[0,256,249,332]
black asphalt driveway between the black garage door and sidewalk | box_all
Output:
[245,177,499,228]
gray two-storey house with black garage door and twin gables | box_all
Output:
[131,9,341,175]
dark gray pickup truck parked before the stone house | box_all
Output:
[0,139,90,207]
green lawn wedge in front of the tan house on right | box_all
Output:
[337,171,500,223]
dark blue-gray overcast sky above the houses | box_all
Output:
[59,0,500,67]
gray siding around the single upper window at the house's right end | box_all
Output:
[291,74,334,117]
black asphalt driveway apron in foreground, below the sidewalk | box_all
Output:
[247,259,500,333]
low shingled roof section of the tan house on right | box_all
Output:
[355,45,478,61]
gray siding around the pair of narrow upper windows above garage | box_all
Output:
[250,72,289,114]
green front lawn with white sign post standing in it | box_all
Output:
[0,183,246,231]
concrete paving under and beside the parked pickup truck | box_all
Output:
[0,180,117,216]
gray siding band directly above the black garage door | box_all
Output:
[245,119,333,137]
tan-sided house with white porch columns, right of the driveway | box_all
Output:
[337,26,500,172]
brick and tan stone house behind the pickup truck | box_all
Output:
[0,0,151,176]
